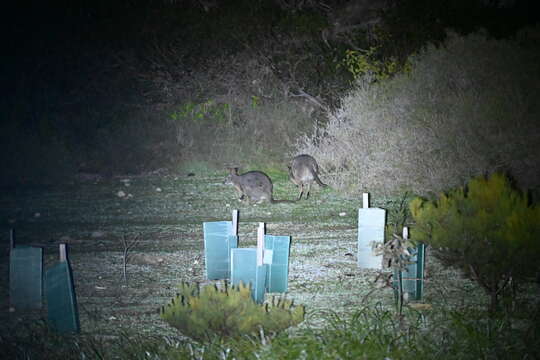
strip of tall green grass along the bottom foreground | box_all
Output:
[0,306,540,360]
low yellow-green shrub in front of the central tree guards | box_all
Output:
[160,283,304,340]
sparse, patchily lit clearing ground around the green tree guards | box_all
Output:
[0,172,536,358]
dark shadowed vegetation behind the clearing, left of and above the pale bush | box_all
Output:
[0,0,535,184]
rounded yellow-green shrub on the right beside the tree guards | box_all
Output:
[410,174,540,312]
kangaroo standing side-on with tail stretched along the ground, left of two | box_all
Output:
[224,168,294,204]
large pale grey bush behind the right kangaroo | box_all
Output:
[297,29,540,193]
